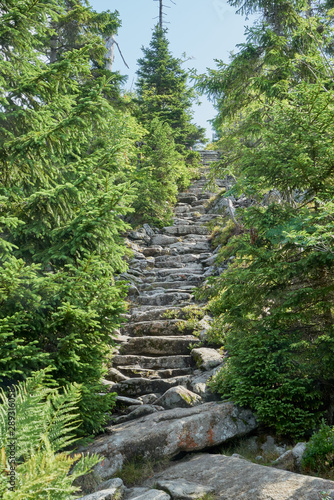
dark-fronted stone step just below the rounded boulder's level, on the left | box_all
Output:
[112,375,190,397]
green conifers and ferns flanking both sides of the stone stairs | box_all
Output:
[0,0,334,499]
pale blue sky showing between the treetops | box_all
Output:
[89,0,253,139]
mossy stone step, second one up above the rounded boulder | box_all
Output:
[122,319,193,337]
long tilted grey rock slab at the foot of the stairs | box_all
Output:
[85,403,257,480]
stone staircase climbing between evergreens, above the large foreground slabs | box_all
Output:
[105,170,227,423]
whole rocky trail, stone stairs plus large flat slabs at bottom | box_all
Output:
[82,156,334,500]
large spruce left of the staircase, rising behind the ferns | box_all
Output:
[0,0,140,432]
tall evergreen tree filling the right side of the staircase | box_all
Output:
[197,0,334,436]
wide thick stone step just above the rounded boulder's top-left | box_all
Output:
[119,335,200,356]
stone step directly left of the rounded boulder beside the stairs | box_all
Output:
[112,354,195,370]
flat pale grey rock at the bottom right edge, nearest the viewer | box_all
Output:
[145,454,334,500]
